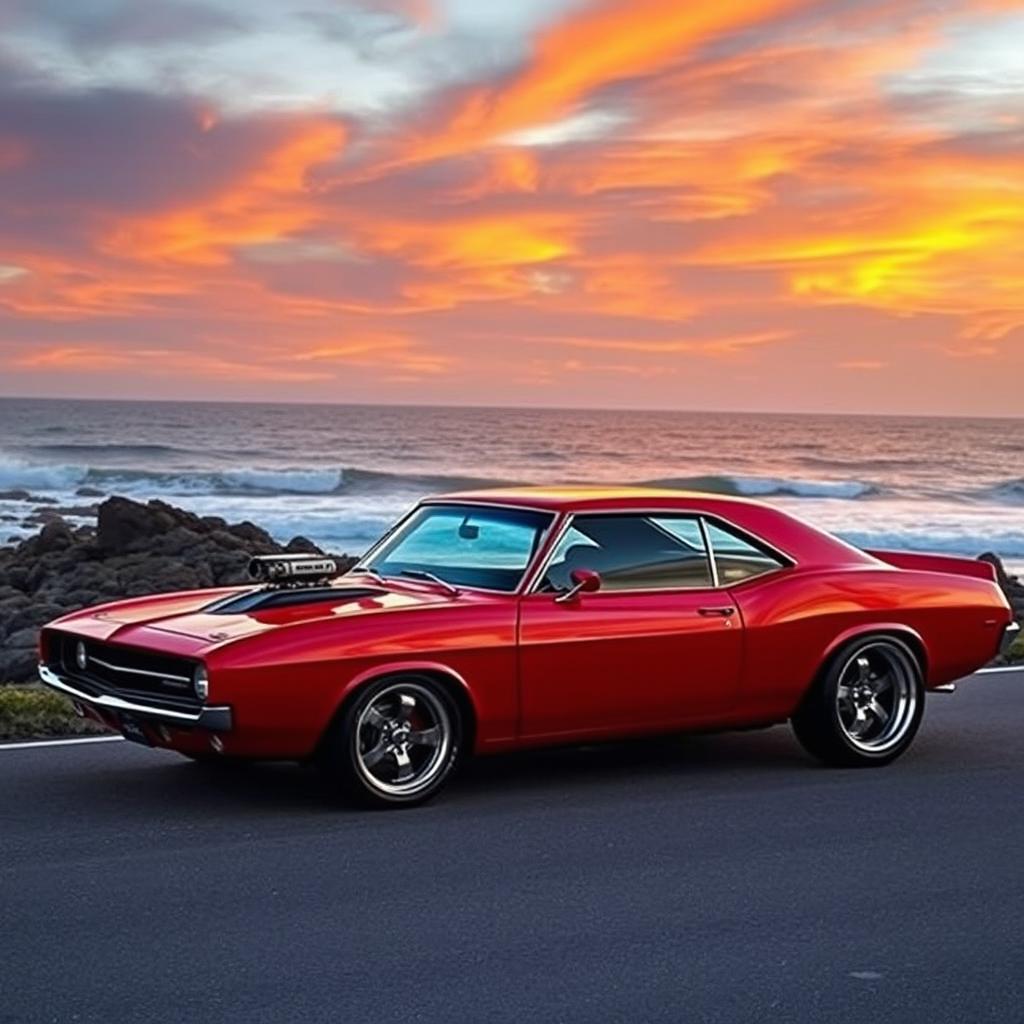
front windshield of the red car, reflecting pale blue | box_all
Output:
[360,505,554,592]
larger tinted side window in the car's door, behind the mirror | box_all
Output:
[542,514,713,591]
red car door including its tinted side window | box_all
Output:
[518,513,743,737]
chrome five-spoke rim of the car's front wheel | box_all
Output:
[355,682,452,798]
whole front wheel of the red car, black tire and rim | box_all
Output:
[316,675,464,808]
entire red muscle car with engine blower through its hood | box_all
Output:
[40,487,1019,806]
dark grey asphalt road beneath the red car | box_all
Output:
[0,673,1024,1024]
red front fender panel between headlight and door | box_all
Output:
[207,598,518,757]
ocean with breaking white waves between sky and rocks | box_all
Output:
[0,398,1024,570]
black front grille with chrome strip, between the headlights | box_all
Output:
[48,633,202,711]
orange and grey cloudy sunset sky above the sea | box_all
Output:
[0,0,1024,415]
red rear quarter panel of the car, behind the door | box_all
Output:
[731,566,1010,718]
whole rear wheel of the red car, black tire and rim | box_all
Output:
[792,636,925,768]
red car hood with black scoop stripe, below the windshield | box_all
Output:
[54,584,460,647]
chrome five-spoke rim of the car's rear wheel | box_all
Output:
[836,642,919,754]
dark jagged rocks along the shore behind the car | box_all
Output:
[0,494,1024,683]
